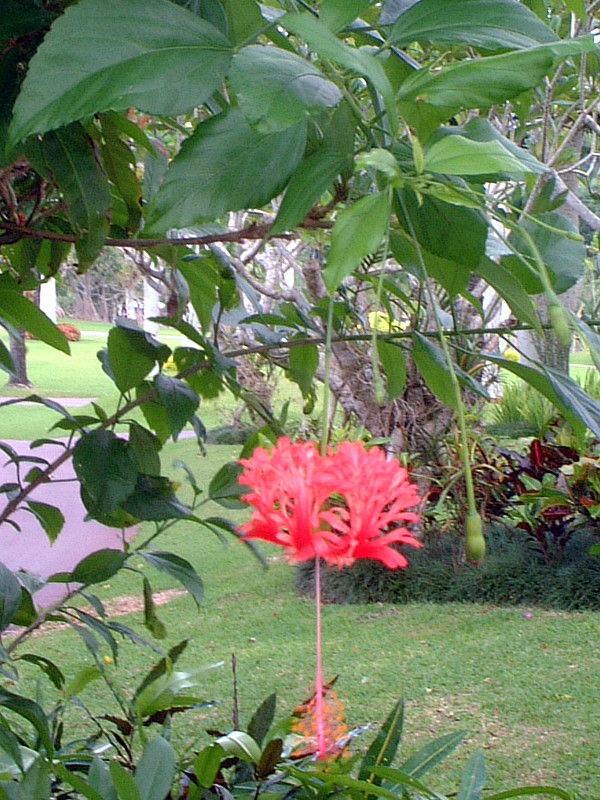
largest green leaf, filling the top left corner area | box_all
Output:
[9,0,231,143]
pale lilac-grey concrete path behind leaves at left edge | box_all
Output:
[0,438,136,607]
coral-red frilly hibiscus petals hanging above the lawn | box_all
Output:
[239,438,421,569]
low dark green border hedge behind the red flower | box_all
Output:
[295,526,600,610]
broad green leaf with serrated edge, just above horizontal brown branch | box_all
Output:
[146,110,306,232]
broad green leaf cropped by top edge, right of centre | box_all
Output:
[388,0,558,51]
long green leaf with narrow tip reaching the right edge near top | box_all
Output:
[397,37,596,138]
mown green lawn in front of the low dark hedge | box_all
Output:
[8,441,600,800]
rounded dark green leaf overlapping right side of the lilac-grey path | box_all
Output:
[73,430,138,514]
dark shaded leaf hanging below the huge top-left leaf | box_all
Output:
[25,122,111,267]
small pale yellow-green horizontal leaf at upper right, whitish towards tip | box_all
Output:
[424,134,546,177]
